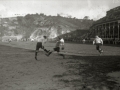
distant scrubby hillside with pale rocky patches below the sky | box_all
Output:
[0,14,94,39]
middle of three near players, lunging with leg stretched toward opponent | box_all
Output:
[47,37,65,58]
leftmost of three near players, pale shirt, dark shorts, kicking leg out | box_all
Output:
[35,36,49,60]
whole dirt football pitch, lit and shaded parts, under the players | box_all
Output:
[0,42,120,90]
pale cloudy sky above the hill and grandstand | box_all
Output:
[0,0,120,20]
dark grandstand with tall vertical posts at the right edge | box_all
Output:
[87,6,120,44]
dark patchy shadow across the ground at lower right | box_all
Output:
[54,56,120,90]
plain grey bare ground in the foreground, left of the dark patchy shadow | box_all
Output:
[0,45,66,90]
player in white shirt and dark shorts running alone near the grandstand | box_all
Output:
[93,35,103,55]
